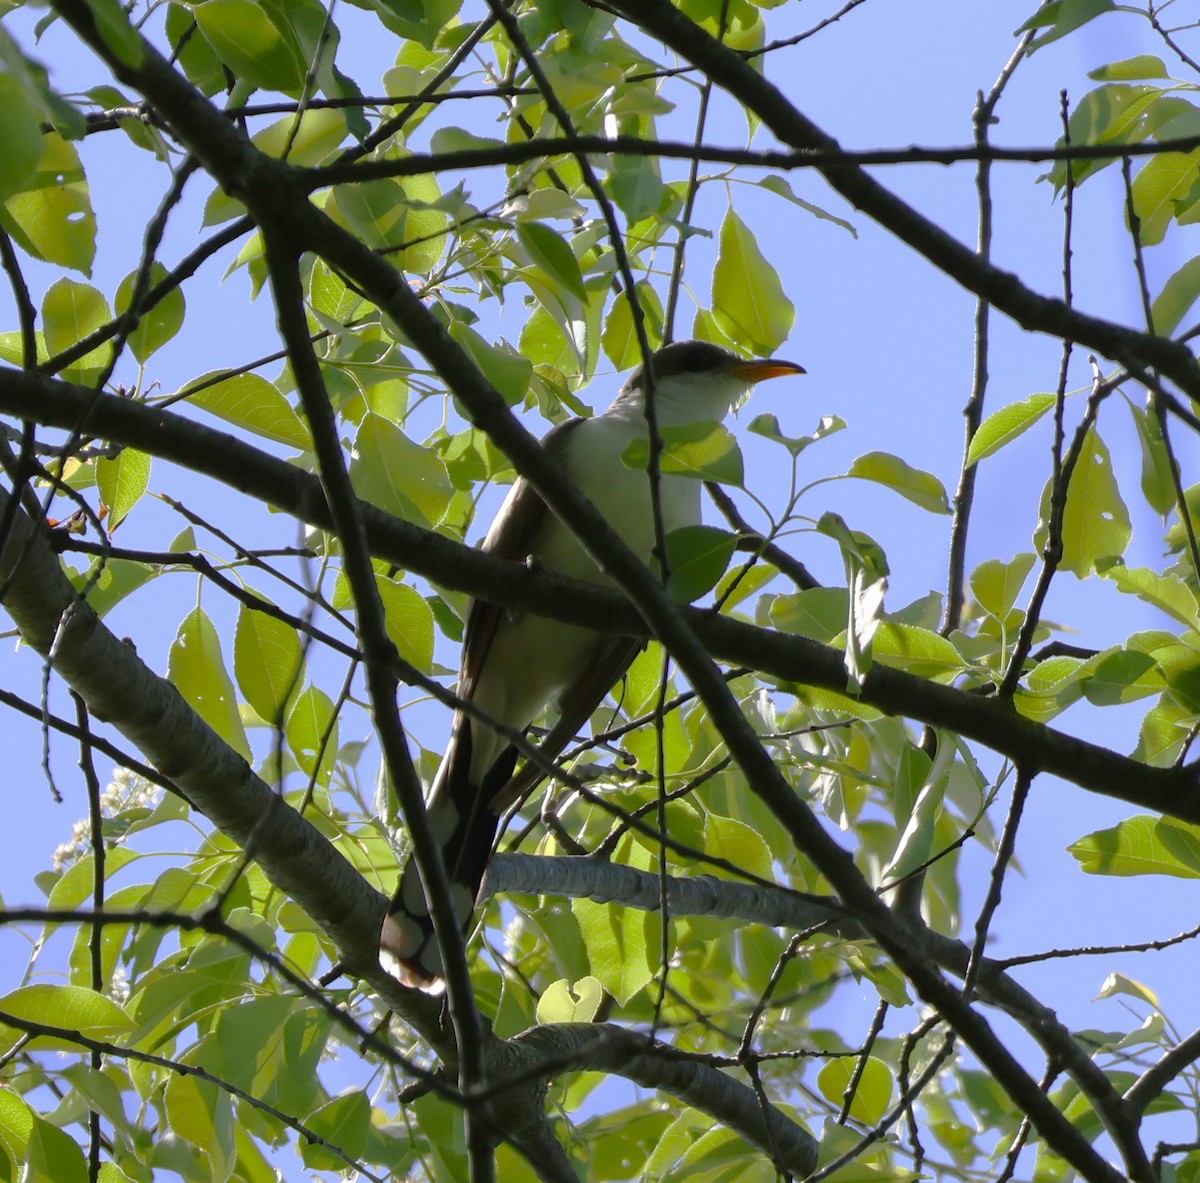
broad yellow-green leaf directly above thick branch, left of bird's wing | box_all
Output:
[350,414,454,527]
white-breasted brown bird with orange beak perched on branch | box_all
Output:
[380,341,805,986]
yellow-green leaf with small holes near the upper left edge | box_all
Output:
[0,132,96,275]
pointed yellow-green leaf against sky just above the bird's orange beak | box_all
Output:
[713,208,796,354]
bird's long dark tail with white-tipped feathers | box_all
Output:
[379,719,517,985]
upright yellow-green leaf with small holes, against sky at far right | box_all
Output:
[1033,427,1133,580]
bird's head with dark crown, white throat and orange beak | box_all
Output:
[617,341,804,422]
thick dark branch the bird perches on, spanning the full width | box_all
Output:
[0,368,1200,823]
